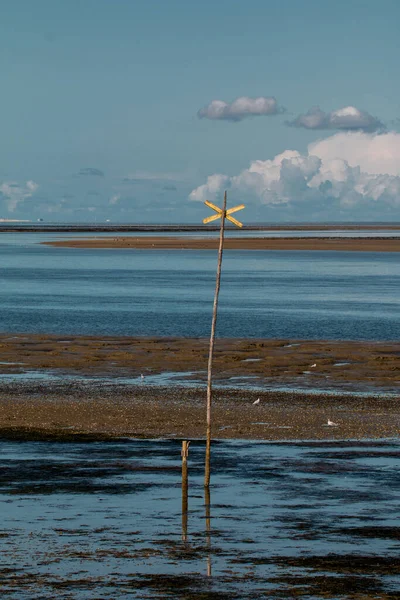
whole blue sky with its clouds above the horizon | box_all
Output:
[0,0,400,223]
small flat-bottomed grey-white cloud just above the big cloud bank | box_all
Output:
[286,106,385,132]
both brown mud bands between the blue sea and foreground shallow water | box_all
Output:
[0,334,400,440]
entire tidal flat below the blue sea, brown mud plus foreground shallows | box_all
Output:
[0,334,400,600]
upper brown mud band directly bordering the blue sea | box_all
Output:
[0,334,400,392]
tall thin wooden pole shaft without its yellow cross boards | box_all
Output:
[204,191,226,488]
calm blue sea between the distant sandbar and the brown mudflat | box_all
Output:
[0,233,400,340]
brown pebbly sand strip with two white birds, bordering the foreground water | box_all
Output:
[0,382,400,441]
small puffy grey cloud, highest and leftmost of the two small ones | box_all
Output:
[197,96,284,121]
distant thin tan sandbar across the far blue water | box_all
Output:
[42,236,400,252]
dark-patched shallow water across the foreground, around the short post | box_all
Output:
[0,440,400,600]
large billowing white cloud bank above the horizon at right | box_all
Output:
[189,132,400,214]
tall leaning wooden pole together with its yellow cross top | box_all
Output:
[203,190,244,488]
